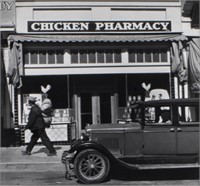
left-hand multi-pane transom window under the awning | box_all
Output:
[24,49,64,65]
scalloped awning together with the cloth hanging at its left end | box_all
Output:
[5,33,188,87]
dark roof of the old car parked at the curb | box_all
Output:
[130,98,200,108]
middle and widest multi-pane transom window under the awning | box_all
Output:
[71,49,122,64]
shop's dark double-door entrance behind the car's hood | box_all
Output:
[78,91,114,130]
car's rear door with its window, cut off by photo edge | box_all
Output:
[177,103,199,155]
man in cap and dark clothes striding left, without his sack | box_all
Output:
[22,96,56,156]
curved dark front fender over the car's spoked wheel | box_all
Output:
[68,141,139,169]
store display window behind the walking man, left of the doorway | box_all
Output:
[19,76,74,124]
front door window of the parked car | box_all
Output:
[145,106,172,125]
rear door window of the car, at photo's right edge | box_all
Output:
[178,105,199,125]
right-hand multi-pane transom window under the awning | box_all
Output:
[128,49,169,63]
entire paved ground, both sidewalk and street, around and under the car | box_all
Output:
[0,145,200,186]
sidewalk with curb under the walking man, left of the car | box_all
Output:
[0,145,69,172]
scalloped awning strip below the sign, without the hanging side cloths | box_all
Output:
[8,34,187,43]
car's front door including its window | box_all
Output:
[143,106,176,155]
